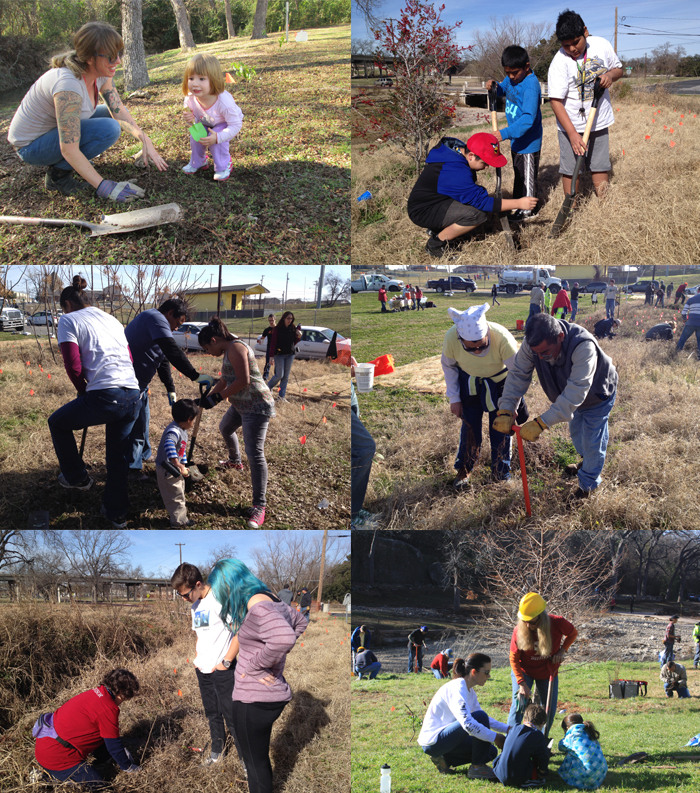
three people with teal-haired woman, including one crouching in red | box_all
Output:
[33,559,308,793]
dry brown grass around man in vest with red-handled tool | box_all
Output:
[362,298,700,529]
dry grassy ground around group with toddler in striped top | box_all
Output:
[0,340,350,529]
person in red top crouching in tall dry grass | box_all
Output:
[32,669,141,790]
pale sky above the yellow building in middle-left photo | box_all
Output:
[3,264,350,300]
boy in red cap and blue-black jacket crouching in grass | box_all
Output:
[408,132,537,257]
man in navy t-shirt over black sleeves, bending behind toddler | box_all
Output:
[124,298,217,482]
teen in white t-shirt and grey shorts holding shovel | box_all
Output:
[547,11,622,196]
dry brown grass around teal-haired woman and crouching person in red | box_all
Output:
[0,604,350,793]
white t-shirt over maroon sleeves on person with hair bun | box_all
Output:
[56,306,139,391]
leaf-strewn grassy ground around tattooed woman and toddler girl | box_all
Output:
[0,25,350,267]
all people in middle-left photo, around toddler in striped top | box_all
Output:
[48,276,301,529]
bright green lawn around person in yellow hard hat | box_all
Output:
[352,662,700,793]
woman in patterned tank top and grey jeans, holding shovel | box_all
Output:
[197,312,276,529]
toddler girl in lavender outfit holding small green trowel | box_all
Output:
[182,53,243,182]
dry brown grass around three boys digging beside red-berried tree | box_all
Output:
[352,85,700,267]
